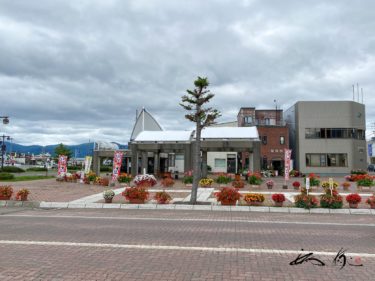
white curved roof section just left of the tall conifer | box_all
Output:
[134,131,192,142]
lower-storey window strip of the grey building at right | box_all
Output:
[306,153,348,167]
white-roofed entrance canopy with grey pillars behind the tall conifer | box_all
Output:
[130,127,260,175]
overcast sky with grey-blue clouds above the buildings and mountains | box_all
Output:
[0,0,375,145]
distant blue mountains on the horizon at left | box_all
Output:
[5,142,128,158]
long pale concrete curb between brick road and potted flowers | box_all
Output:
[33,202,375,215]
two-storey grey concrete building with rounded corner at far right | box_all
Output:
[284,101,367,174]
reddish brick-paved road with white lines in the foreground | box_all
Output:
[0,209,375,281]
